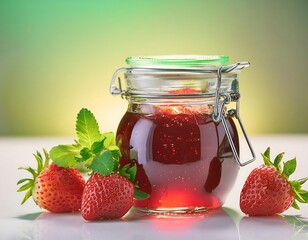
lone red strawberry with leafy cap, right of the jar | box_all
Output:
[240,148,308,216]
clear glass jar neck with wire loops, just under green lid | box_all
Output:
[110,62,249,99]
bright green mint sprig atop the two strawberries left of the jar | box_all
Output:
[50,108,149,200]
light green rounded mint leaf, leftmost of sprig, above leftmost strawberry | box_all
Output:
[49,145,82,168]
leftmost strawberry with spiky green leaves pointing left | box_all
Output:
[17,149,85,213]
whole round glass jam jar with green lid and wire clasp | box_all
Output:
[110,56,254,213]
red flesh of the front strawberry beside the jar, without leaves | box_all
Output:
[81,173,134,221]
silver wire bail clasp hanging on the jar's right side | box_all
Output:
[212,62,255,167]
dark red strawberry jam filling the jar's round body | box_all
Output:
[117,104,239,212]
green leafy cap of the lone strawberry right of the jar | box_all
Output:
[262,147,308,209]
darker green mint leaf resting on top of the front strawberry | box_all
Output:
[88,151,113,176]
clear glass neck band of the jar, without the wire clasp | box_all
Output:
[125,70,239,99]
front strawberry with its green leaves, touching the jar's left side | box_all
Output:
[81,158,149,221]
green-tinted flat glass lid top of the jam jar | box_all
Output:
[126,55,229,69]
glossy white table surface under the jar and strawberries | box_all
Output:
[0,135,308,240]
